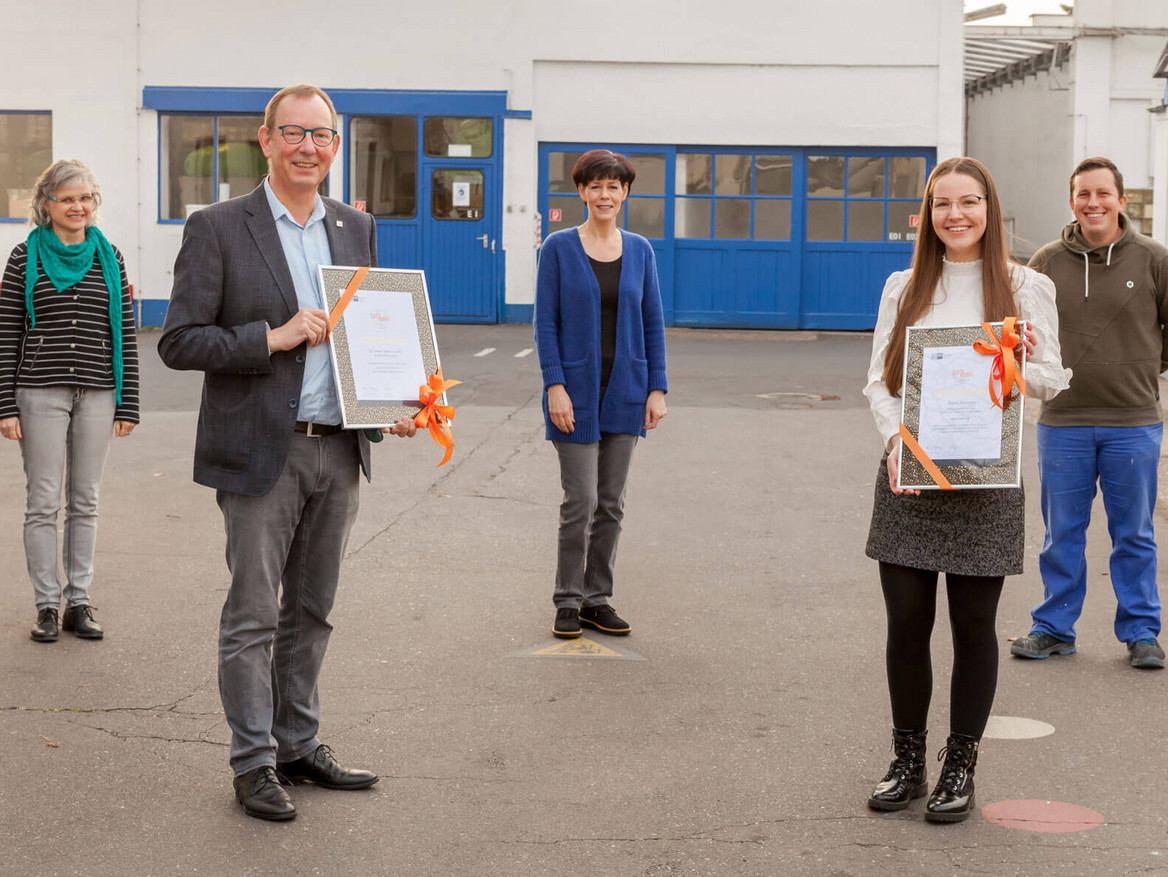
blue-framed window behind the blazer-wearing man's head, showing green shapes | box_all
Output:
[159,113,267,221]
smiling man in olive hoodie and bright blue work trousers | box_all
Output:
[1010,158,1168,668]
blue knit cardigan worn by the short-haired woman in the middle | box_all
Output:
[535,228,669,444]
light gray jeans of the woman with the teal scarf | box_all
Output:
[16,387,114,610]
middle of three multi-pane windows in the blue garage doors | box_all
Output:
[673,152,794,241]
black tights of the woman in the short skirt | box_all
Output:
[880,563,1004,739]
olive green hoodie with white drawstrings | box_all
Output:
[1030,214,1168,426]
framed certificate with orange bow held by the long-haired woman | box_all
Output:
[898,318,1026,490]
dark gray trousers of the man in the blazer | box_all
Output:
[216,432,360,775]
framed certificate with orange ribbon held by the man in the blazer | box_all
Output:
[320,265,445,429]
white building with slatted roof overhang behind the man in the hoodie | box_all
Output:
[965,0,1168,258]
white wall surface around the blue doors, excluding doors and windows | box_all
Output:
[0,0,964,312]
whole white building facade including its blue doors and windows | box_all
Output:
[0,0,964,328]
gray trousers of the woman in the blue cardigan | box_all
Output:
[551,432,638,608]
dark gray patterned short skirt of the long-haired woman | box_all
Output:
[864,454,1026,576]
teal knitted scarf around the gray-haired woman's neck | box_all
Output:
[25,225,123,405]
